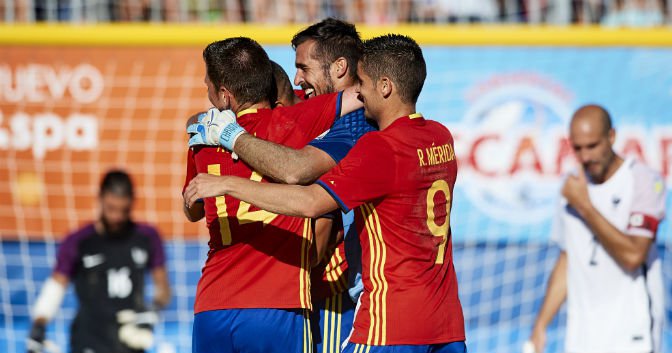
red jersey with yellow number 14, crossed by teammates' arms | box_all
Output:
[185,94,340,313]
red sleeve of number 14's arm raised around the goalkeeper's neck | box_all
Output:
[269,93,342,147]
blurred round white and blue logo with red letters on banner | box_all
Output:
[455,73,573,223]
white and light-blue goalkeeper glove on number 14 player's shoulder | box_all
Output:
[187,108,245,151]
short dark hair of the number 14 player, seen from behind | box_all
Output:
[203,37,272,104]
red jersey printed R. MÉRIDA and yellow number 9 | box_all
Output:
[318,114,465,346]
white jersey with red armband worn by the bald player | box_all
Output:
[551,159,665,353]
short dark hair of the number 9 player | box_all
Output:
[361,34,427,103]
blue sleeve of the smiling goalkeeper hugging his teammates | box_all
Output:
[309,108,377,163]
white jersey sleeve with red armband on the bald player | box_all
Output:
[626,163,665,238]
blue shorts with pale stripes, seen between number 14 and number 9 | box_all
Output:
[310,291,355,353]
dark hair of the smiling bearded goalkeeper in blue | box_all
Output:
[292,17,362,78]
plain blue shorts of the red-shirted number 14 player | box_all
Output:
[192,309,312,353]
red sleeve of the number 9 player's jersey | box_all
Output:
[317,133,397,212]
